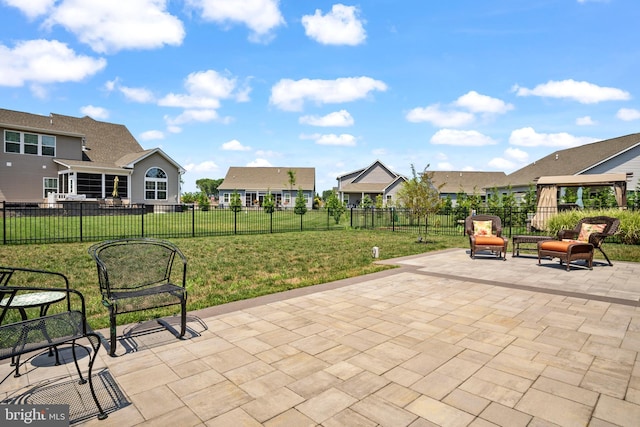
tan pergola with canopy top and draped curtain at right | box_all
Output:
[531,173,627,230]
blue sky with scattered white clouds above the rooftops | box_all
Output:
[0,0,640,193]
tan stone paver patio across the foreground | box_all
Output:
[0,249,640,427]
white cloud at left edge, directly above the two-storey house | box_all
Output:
[0,40,107,87]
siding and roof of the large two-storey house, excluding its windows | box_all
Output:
[0,108,184,203]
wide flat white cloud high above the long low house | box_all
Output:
[269,77,387,111]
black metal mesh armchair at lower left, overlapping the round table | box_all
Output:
[0,267,107,420]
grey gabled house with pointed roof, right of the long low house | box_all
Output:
[337,160,407,207]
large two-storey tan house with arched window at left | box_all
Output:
[0,109,185,204]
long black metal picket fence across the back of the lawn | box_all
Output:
[0,202,556,244]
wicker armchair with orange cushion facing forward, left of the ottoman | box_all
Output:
[465,215,509,261]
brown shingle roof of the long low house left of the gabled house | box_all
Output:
[218,166,316,191]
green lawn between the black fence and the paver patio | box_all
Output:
[0,230,640,328]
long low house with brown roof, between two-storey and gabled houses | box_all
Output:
[218,166,316,209]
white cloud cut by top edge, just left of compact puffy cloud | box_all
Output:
[186,0,285,42]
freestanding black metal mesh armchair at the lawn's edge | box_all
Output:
[89,238,187,356]
